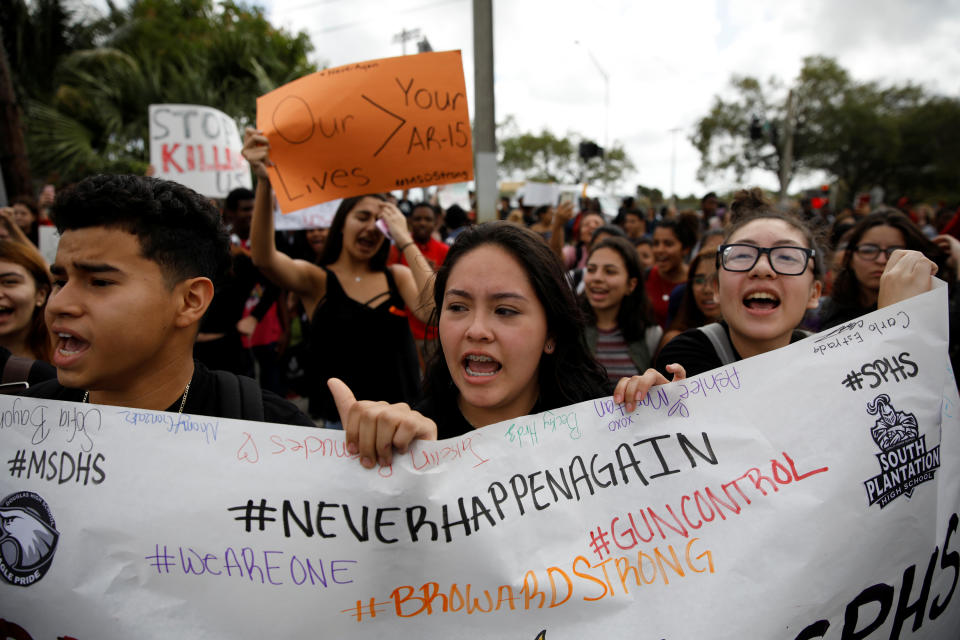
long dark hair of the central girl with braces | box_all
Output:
[424,221,610,410]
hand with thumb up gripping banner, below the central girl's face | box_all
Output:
[327,378,437,469]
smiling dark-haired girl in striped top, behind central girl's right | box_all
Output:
[581,237,663,382]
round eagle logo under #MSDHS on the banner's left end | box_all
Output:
[0,491,60,587]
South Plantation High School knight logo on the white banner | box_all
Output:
[863,393,940,509]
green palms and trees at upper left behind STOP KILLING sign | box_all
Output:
[2,0,315,185]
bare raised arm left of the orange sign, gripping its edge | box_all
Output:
[243,127,327,306]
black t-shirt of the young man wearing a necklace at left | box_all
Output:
[21,360,316,427]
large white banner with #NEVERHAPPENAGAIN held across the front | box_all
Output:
[0,288,960,640]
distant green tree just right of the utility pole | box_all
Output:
[497,116,634,189]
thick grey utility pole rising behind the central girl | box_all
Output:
[473,0,497,222]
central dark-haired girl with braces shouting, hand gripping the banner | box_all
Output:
[329,222,610,467]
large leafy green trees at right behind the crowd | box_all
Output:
[691,57,960,204]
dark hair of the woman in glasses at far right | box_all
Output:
[830,211,954,308]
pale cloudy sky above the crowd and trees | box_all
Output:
[262,0,960,199]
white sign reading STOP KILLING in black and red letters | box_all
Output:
[149,104,253,198]
